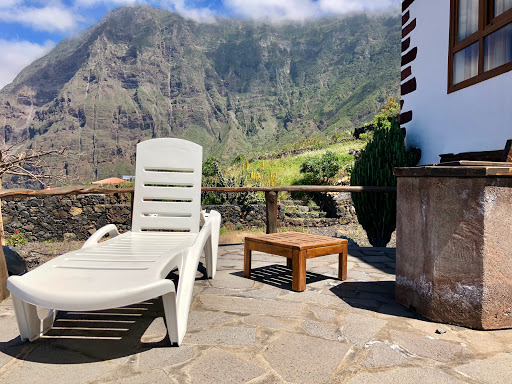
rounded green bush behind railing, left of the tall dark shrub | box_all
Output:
[300,151,340,185]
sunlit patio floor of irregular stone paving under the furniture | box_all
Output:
[0,245,512,384]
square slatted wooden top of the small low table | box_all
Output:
[245,232,348,251]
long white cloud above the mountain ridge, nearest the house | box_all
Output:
[224,0,399,20]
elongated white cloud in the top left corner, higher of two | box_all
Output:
[0,4,81,32]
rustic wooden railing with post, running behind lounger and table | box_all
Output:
[0,185,396,233]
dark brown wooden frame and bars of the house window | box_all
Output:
[448,0,512,93]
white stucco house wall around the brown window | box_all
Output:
[402,0,512,164]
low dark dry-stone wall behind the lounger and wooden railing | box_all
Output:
[2,194,357,241]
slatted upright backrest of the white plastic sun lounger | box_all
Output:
[132,138,203,233]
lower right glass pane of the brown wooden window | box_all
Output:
[484,23,512,71]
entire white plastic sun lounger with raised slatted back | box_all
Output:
[7,139,220,345]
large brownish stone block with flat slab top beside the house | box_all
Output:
[395,166,512,329]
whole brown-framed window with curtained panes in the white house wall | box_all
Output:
[448,0,512,93]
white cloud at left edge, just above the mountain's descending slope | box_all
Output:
[0,39,55,88]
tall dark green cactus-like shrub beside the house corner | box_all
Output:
[350,117,419,247]
